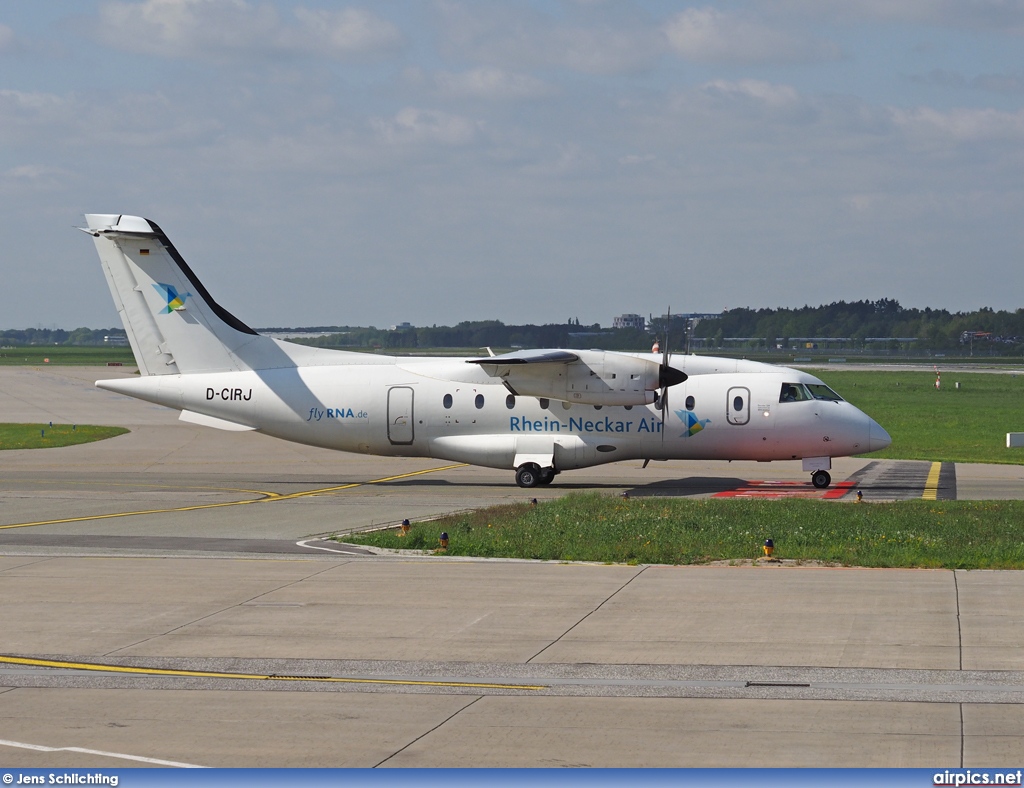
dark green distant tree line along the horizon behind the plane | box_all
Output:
[8,299,1024,355]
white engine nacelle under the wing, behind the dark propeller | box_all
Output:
[473,350,686,405]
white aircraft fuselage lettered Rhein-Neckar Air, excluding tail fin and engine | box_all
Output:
[97,356,888,471]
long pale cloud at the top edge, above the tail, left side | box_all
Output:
[97,0,402,60]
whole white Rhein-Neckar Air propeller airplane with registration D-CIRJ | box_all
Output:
[81,214,891,488]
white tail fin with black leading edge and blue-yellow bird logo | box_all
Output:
[83,214,285,375]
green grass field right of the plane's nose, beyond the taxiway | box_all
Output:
[819,371,1024,464]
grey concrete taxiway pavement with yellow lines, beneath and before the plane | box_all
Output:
[0,367,1024,768]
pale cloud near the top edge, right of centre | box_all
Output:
[664,8,840,63]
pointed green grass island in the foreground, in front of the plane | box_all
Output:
[338,493,1024,569]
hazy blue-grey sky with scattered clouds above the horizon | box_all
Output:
[0,0,1024,329]
